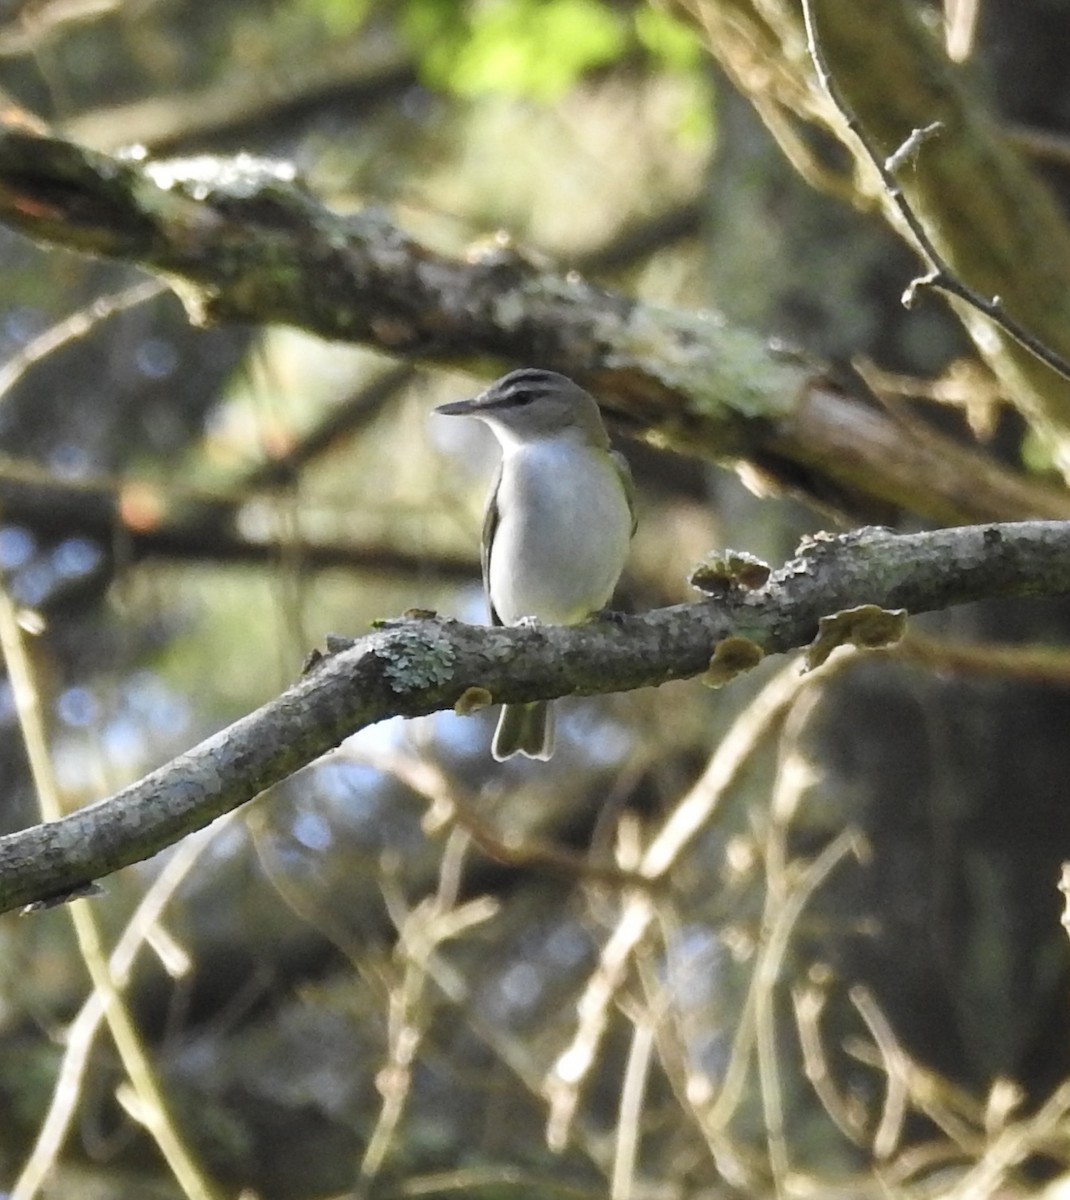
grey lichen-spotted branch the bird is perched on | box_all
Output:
[0,522,1070,912]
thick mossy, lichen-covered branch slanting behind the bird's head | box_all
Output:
[0,128,1070,524]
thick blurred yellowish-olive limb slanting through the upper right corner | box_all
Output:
[677,0,1070,444]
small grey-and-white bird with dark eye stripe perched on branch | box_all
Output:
[435,367,636,762]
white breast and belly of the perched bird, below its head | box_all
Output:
[489,439,631,625]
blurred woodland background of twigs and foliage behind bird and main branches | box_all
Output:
[0,0,1070,1200]
